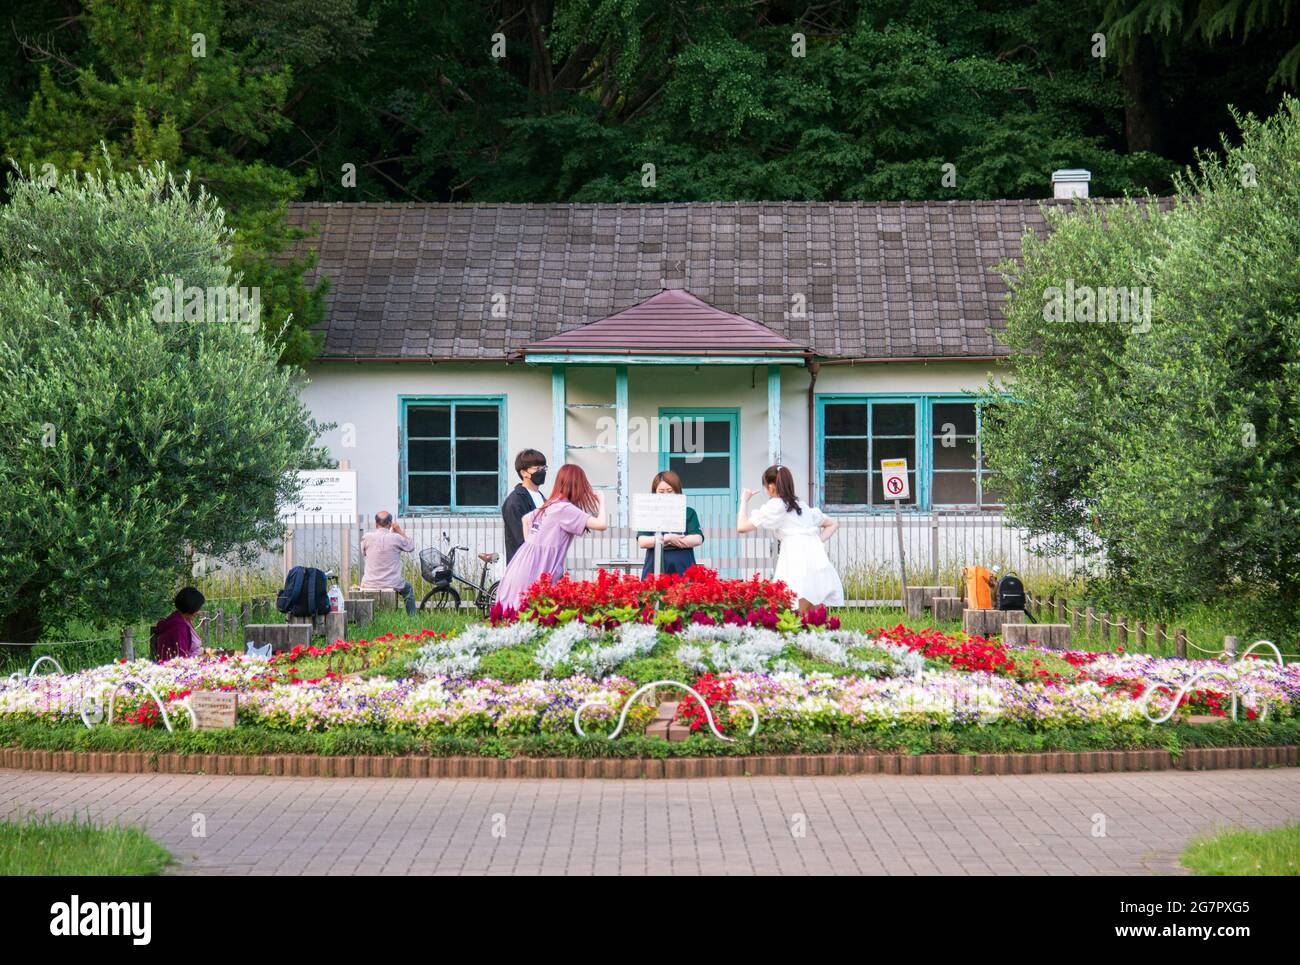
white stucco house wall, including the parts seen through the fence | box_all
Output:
[287,362,1097,598]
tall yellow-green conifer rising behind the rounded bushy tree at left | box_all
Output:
[0,0,364,363]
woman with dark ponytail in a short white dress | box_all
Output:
[736,466,844,613]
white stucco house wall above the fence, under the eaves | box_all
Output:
[302,362,995,514]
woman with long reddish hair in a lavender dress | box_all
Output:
[497,463,610,610]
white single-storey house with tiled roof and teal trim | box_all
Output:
[282,172,1087,585]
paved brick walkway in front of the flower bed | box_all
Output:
[0,769,1300,875]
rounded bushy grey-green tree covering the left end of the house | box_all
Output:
[0,164,320,641]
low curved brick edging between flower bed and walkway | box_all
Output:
[0,744,1300,779]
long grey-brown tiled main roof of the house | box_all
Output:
[289,200,1107,359]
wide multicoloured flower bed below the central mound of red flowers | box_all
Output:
[0,622,1300,753]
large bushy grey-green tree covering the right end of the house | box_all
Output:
[985,98,1300,632]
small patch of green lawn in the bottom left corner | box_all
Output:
[0,815,173,875]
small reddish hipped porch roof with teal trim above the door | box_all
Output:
[523,289,809,363]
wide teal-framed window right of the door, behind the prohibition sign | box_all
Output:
[814,393,1002,514]
